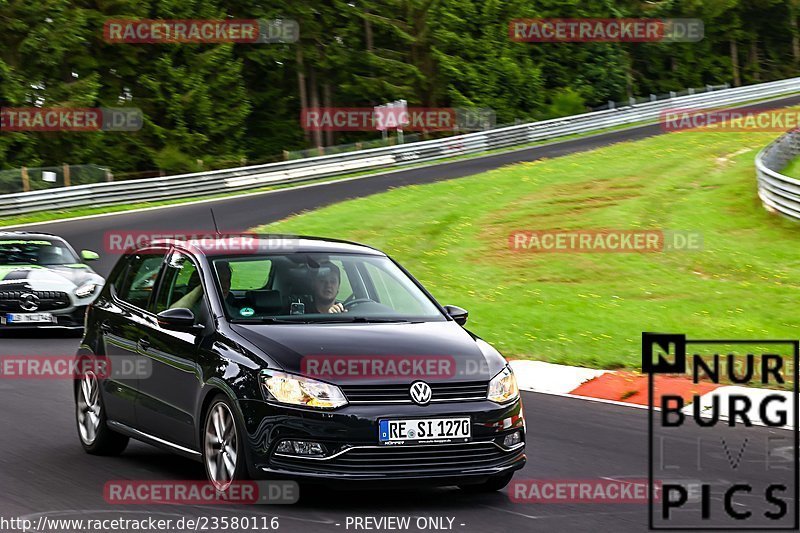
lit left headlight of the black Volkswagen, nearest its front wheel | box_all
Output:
[261,370,347,409]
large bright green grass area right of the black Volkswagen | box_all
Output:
[259,132,800,368]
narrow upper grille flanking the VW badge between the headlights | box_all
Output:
[340,381,489,404]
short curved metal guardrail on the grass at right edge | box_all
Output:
[756,130,800,220]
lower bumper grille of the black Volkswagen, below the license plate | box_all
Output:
[272,441,523,475]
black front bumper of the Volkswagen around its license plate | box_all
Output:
[239,394,526,486]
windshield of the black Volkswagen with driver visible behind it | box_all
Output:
[212,253,446,323]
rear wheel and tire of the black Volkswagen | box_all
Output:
[75,372,130,456]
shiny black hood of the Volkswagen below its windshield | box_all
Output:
[231,321,506,385]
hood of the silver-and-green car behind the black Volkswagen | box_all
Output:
[0,263,103,292]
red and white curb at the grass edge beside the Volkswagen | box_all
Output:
[509,360,794,429]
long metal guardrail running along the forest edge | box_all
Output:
[0,78,800,217]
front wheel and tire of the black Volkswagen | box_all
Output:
[200,394,247,491]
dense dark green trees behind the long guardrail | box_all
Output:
[0,0,800,172]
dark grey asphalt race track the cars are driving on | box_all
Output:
[0,97,800,532]
